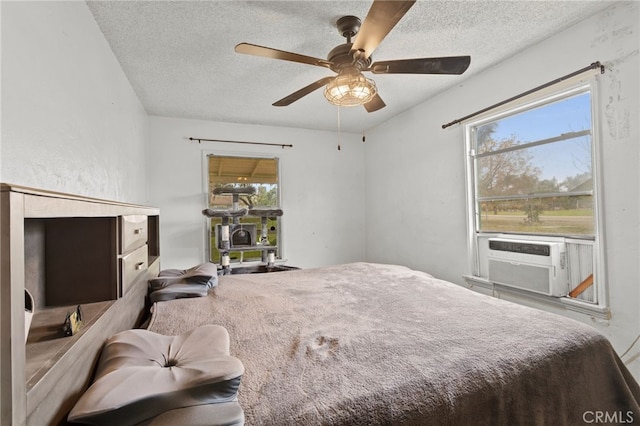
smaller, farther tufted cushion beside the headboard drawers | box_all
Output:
[149,262,218,303]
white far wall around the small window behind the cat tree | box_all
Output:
[148,116,364,268]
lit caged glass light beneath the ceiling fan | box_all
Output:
[324,70,378,106]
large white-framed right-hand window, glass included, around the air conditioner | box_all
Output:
[466,83,606,310]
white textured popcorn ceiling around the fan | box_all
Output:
[87,0,611,133]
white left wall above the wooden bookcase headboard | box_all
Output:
[0,1,148,203]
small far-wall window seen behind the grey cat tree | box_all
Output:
[207,155,280,263]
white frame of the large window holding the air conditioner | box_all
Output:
[463,77,610,318]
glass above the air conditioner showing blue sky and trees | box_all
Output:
[472,91,595,236]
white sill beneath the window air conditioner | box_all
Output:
[462,275,611,319]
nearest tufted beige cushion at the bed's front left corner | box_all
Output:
[68,325,244,426]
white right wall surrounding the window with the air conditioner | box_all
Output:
[365,2,640,378]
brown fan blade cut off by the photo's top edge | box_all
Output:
[351,0,416,58]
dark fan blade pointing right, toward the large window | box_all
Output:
[369,56,471,75]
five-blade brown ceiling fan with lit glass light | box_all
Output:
[235,0,471,112]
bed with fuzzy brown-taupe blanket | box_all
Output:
[148,263,640,426]
